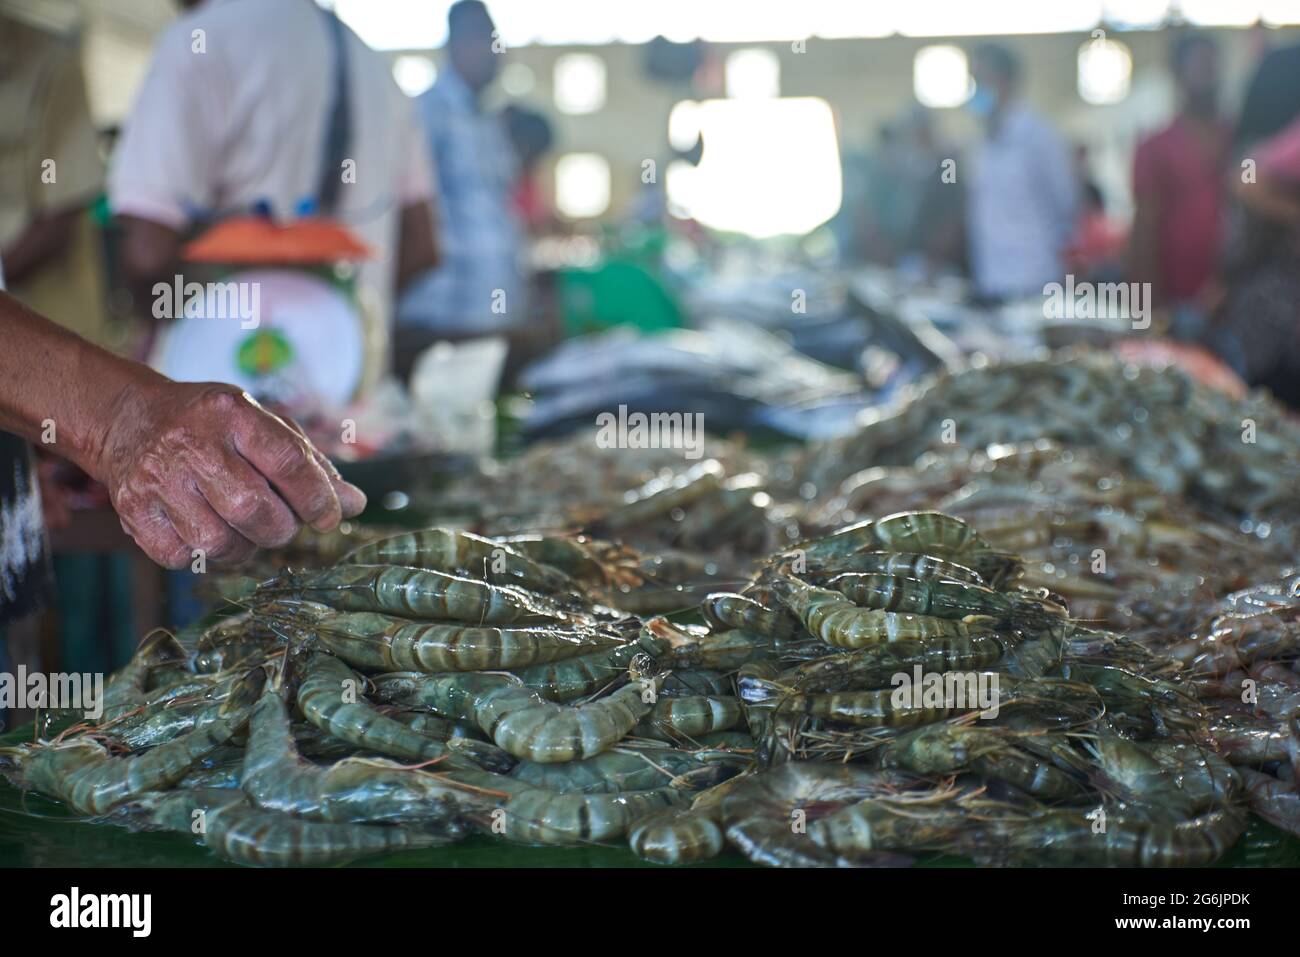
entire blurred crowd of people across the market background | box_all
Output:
[10,0,1300,403]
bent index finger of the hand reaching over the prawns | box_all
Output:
[233,408,343,532]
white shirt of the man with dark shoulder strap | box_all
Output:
[109,0,433,322]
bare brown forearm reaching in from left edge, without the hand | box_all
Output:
[0,293,166,477]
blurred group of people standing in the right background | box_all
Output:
[836,33,1300,406]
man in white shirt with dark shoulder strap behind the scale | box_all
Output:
[109,0,437,642]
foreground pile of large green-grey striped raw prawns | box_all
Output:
[0,511,1300,866]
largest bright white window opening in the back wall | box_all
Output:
[664,96,841,239]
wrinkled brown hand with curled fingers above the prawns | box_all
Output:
[95,380,365,568]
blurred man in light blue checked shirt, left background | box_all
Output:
[398,0,528,371]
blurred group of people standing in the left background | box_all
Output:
[0,0,553,382]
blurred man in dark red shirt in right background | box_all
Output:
[1128,34,1231,338]
